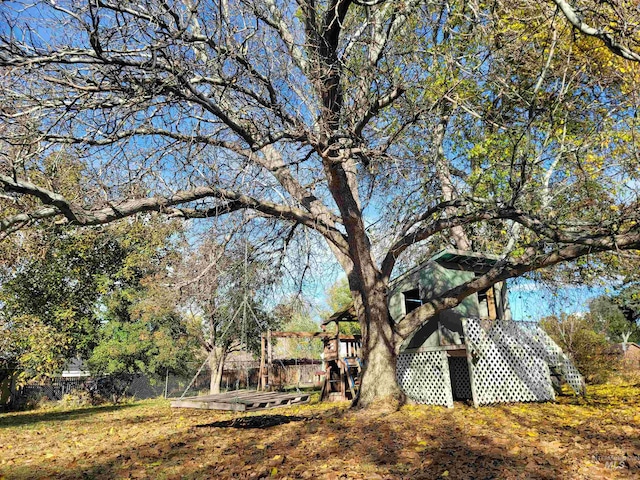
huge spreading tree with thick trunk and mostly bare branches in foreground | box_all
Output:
[0,0,640,405]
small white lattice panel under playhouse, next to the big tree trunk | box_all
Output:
[396,351,453,407]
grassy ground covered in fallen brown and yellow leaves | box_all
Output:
[0,382,640,480]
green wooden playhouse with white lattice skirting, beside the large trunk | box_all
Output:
[389,250,584,407]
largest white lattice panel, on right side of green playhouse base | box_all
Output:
[464,319,554,405]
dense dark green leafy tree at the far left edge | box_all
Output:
[0,232,126,375]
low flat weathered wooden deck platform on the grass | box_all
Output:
[171,390,310,412]
